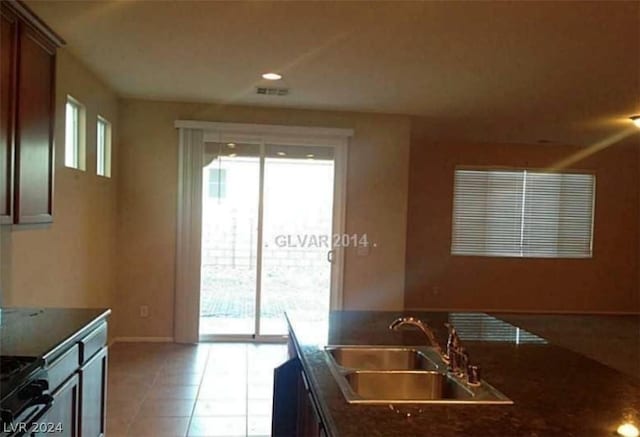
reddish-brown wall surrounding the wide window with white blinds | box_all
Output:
[405,138,640,312]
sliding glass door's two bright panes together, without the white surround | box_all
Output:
[200,141,339,340]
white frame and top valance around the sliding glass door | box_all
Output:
[174,120,354,343]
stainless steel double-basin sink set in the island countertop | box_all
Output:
[325,346,513,404]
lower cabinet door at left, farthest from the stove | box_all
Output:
[80,346,107,437]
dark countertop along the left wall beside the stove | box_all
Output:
[0,308,111,397]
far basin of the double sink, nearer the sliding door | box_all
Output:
[326,346,438,370]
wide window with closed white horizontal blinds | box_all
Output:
[451,169,595,258]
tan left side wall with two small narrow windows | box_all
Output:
[0,49,118,307]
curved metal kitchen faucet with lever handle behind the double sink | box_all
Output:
[389,317,480,386]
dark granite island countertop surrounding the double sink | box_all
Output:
[287,311,640,437]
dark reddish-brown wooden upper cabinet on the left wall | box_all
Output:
[0,1,63,224]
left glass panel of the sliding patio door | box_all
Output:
[200,143,260,336]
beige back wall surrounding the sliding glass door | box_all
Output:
[113,99,410,337]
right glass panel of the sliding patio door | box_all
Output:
[258,145,334,335]
